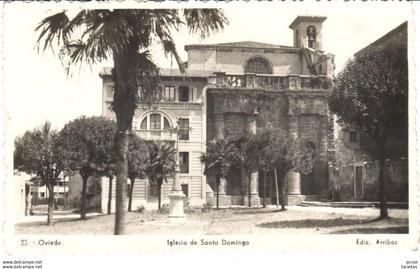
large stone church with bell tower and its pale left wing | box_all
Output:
[100,16,334,209]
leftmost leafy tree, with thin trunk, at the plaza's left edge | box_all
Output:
[14,122,64,225]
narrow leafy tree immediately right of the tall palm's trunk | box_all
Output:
[127,135,149,211]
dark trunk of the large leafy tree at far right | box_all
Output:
[378,137,388,219]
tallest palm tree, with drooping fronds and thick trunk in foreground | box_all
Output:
[35,9,227,234]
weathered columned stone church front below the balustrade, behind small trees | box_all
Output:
[209,90,328,206]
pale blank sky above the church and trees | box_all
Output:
[3,1,412,137]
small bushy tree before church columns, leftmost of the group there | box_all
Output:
[200,140,241,208]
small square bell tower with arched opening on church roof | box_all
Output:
[289,16,327,50]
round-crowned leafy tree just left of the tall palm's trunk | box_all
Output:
[58,116,115,219]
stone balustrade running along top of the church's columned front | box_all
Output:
[209,72,332,91]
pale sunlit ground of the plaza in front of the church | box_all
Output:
[15,206,408,235]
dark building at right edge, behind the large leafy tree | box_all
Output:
[330,22,408,202]
